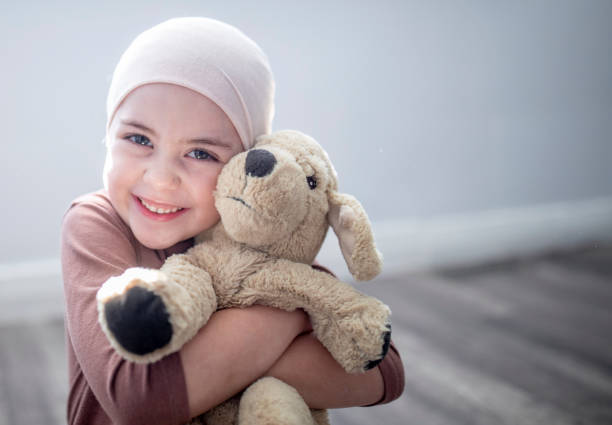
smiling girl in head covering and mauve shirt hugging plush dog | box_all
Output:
[62,18,404,425]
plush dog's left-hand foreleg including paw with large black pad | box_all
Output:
[97,255,217,363]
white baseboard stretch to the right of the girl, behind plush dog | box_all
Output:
[318,198,612,280]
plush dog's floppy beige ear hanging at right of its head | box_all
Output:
[327,191,382,280]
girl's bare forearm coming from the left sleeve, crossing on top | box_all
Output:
[181,305,310,417]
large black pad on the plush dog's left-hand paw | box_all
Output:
[104,286,172,355]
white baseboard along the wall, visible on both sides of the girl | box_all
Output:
[0,198,612,322]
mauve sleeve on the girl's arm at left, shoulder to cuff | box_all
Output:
[62,197,189,425]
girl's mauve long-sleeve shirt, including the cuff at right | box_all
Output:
[62,190,404,425]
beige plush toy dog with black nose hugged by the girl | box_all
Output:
[97,131,391,424]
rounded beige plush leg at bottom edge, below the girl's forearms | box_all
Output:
[238,377,329,425]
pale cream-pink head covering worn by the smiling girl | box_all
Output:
[106,17,274,149]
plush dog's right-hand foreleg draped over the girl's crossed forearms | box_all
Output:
[236,260,391,373]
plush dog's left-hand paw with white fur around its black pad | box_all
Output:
[97,268,173,363]
